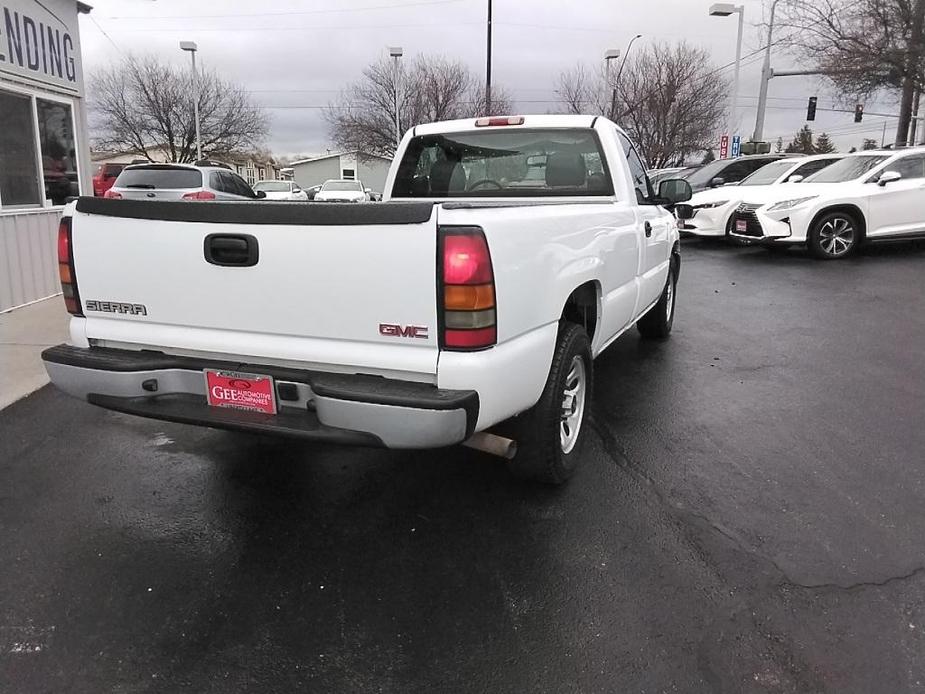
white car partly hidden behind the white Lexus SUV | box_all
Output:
[682,154,845,236]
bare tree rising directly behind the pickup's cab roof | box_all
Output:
[325,55,511,156]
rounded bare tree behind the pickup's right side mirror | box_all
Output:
[614,42,729,168]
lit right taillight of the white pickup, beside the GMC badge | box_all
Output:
[439,227,498,350]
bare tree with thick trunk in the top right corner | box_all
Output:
[782,0,925,144]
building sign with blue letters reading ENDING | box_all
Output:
[0,0,83,93]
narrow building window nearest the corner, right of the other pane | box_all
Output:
[35,99,80,205]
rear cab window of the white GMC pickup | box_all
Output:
[392,128,613,198]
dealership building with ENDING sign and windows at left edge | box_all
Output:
[0,0,92,311]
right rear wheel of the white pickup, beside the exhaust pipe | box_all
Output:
[508,323,593,484]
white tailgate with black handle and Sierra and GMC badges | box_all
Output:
[72,198,438,378]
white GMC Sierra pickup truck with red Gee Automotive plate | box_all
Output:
[43,115,690,483]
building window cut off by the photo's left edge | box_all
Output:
[0,91,42,207]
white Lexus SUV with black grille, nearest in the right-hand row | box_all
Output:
[730,147,925,260]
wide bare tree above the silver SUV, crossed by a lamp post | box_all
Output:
[89,57,268,162]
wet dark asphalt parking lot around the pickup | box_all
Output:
[0,241,925,693]
